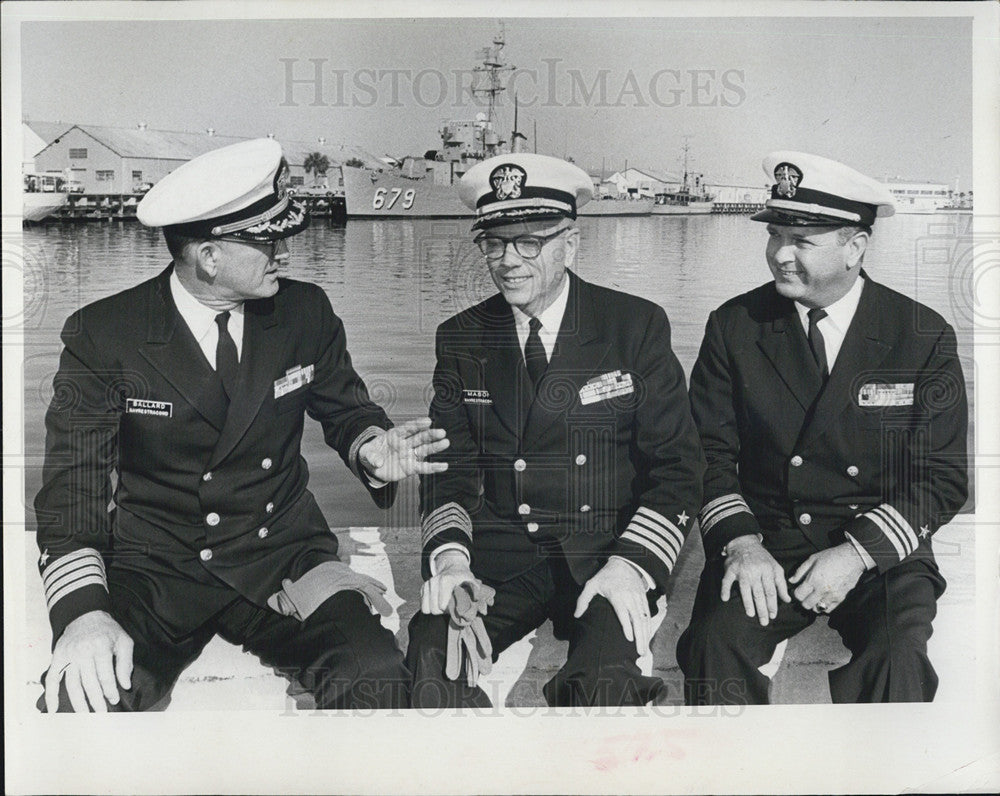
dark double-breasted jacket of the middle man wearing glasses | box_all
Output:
[421,273,704,588]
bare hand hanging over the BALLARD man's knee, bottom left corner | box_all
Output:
[45,611,132,713]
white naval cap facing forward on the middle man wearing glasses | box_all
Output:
[458,152,594,229]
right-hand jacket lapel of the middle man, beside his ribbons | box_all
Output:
[524,272,611,439]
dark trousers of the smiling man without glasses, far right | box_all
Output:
[677,548,945,705]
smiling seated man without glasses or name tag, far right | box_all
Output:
[677,152,968,704]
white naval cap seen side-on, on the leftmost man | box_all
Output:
[136,138,309,242]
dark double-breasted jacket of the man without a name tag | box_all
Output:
[691,272,968,570]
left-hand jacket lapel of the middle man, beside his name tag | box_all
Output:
[480,295,532,438]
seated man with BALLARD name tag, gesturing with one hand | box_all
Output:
[35,139,447,711]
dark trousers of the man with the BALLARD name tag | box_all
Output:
[38,581,411,712]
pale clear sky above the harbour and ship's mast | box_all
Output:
[21,13,973,189]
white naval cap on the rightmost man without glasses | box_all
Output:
[752,150,896,227]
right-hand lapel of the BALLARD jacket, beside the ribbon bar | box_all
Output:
[208,299,288,468]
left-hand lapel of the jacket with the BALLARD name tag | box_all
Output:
[139,265,225,430]
